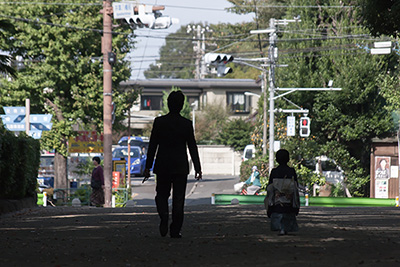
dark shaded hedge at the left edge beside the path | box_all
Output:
[0,125,40,199]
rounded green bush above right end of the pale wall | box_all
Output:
[217,119,253,151]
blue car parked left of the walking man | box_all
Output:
[112,146,146,176]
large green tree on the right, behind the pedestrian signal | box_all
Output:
[268,0,393,195]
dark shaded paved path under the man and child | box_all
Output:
[0,205,400,266]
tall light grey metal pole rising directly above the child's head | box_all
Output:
[268,19,277,172]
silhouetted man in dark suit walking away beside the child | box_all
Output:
[143,91,202,238]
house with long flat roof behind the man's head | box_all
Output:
[120,79,261,131]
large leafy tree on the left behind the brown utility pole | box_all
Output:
[0,0,133,191]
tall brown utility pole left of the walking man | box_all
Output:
[102,0,112,207]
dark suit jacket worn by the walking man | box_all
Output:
[146,113,201,174]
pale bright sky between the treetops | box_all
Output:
[127,0,254,79]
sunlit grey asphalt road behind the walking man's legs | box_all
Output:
[130,175,239,206]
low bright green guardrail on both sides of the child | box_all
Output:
[211,194,397,207]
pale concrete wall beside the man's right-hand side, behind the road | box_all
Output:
[191,145,242,176]
